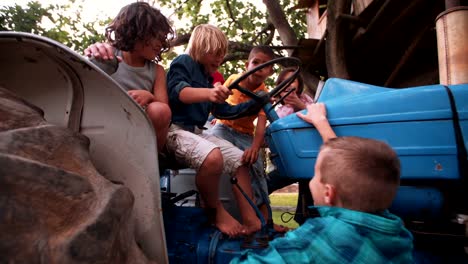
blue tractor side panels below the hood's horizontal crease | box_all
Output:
[269,120,459,179]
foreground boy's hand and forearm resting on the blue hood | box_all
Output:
[296,103,336,142]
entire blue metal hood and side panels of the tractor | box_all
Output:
[267,79,458,180]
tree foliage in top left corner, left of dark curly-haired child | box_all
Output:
[0,0,110,52]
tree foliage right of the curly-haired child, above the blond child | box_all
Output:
[158,0,307,83]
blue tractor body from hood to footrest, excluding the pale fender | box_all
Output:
[160,63,468,263]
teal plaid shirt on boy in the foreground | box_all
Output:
[231,207,413,264]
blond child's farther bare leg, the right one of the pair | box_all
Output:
[233,166,261,234]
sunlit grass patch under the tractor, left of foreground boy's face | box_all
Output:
[270,193,299,228]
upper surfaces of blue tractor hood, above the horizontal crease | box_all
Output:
[269,79,452,132]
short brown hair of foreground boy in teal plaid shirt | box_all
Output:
[319,137,400,213]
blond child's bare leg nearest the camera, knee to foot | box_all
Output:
[195,148,243,236]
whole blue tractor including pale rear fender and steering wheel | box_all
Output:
[0,3,468,263]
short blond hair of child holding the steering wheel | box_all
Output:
[187,24,228,62]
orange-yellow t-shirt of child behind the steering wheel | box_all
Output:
[217,74,268,135]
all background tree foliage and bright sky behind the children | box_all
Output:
[0,0,307,84]
